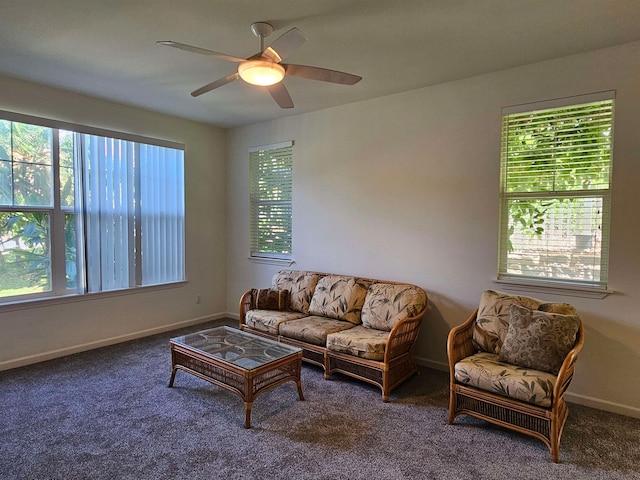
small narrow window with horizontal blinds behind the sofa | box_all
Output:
[249,142,293,260]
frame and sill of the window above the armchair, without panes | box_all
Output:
[495,91,615,298]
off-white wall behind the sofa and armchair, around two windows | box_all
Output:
[227,43,640,417]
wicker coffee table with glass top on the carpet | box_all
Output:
[169,326,304,428]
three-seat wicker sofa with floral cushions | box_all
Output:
[240,270,428,402]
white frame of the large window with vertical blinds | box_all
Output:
[0,110,187,304]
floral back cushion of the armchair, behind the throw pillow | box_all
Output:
[472,290,576,355]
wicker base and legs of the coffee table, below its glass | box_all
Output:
[169,342,304,428]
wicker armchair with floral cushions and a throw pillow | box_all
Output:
[447,290,584,463]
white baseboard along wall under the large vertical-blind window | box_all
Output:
[0,313,229,371]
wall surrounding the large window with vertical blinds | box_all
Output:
[0,77,226,370]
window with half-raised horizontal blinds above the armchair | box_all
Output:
[498,92,614,289]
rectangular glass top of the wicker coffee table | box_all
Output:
[171,326,301,370]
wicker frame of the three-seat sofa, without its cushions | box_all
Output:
[239,272,428,402]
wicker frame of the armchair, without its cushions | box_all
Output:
[447,310,584,463]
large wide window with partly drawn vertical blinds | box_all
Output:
[0,112,184,302]
